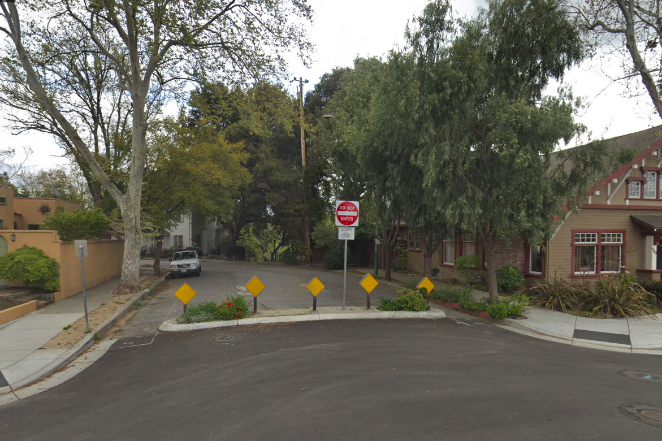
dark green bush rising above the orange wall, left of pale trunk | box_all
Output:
[39,206,110,242]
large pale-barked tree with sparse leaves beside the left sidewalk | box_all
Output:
[0,0,311,293]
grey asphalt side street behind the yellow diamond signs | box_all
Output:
[118,260,396,341]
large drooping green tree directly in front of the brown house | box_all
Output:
[423,0,608,301]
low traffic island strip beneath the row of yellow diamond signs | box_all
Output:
[159,307,446,332]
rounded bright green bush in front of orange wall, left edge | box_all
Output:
[0,245,60,291]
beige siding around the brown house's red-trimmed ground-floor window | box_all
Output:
[545,207,662,278]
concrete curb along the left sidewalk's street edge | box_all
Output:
[0,274,167,393]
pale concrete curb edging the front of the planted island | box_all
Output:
[159,310,446,332]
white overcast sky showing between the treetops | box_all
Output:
[0,0,660,168]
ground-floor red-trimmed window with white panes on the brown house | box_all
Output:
[573,231,625,274]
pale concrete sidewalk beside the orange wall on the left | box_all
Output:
[0,268,152,393]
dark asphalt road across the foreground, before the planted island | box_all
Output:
[0,319,662,441]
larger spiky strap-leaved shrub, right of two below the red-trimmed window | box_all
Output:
[583,274,655,317]
